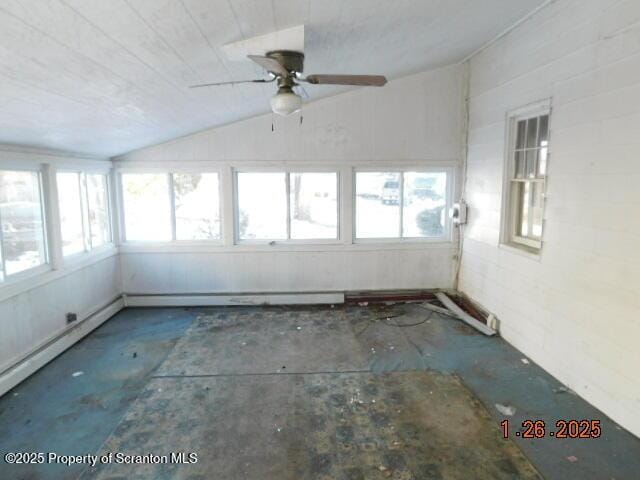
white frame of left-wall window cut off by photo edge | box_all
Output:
[0,166,52,282]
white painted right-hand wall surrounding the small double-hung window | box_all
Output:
[459,0,640,435]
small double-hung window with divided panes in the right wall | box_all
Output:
[504,109,549,251]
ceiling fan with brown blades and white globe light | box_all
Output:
[189,50,387,116]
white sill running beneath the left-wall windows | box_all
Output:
[0,245,118,302]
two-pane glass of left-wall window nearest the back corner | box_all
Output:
[56,172,111,256]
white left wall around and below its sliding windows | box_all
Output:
[0,145,121,382]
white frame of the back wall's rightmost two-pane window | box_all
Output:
[351,168,455,244]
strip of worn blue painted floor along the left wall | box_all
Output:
[0,309,194,479]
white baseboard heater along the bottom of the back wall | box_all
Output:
[123,292,344,307]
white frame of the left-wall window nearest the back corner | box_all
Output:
[53,166,114,262]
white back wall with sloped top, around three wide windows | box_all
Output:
[115,66,463,293]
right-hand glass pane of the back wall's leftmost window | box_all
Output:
[173,173,220,240]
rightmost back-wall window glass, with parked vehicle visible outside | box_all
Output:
[355,171,448,239]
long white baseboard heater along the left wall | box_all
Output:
[0,297,124,396]
